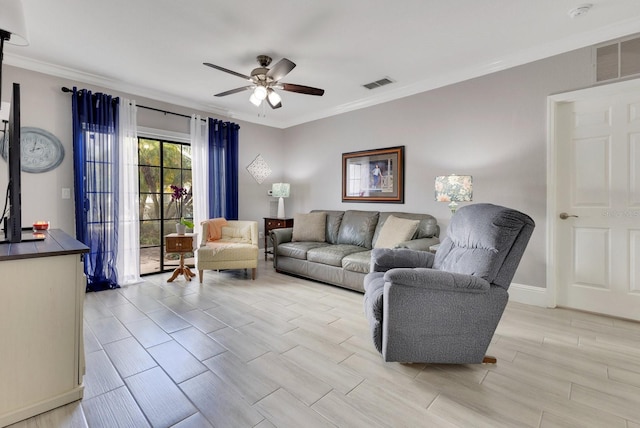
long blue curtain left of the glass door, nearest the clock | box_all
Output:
[72,87,119,291]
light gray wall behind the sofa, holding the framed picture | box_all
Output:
[285,49,591,287]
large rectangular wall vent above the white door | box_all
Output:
[593,34,640,82]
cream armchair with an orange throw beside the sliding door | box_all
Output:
[196,219,258,283]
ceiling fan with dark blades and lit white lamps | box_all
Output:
[203,55,324,109]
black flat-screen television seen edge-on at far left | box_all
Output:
[5,83,22,242]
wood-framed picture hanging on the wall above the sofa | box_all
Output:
[342,146,404,204]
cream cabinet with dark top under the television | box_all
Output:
[0,231,86,426]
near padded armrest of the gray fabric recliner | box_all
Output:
[384,268,491,293]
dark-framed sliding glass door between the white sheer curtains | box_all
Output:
[138,138,193,275]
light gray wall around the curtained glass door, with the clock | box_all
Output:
[0,65,283,236]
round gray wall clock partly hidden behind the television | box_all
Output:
[2,127,64,173]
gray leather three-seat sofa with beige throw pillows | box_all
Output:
[271,210,440,292]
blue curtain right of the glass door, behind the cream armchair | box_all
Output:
[209,118,240,220]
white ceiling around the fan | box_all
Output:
[5,0,640,128]
